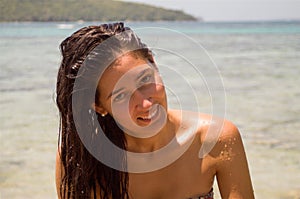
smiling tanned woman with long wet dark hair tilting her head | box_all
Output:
[56,23,254,199]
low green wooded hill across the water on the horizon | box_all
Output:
[0,0,197,22]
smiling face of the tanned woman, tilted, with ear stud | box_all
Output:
[96,54,167,138]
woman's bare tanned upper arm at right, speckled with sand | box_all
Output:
[216,122,254,199]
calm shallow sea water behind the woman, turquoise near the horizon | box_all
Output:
[0,22,300,199]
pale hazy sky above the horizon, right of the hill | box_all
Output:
[121,0,300,21]
